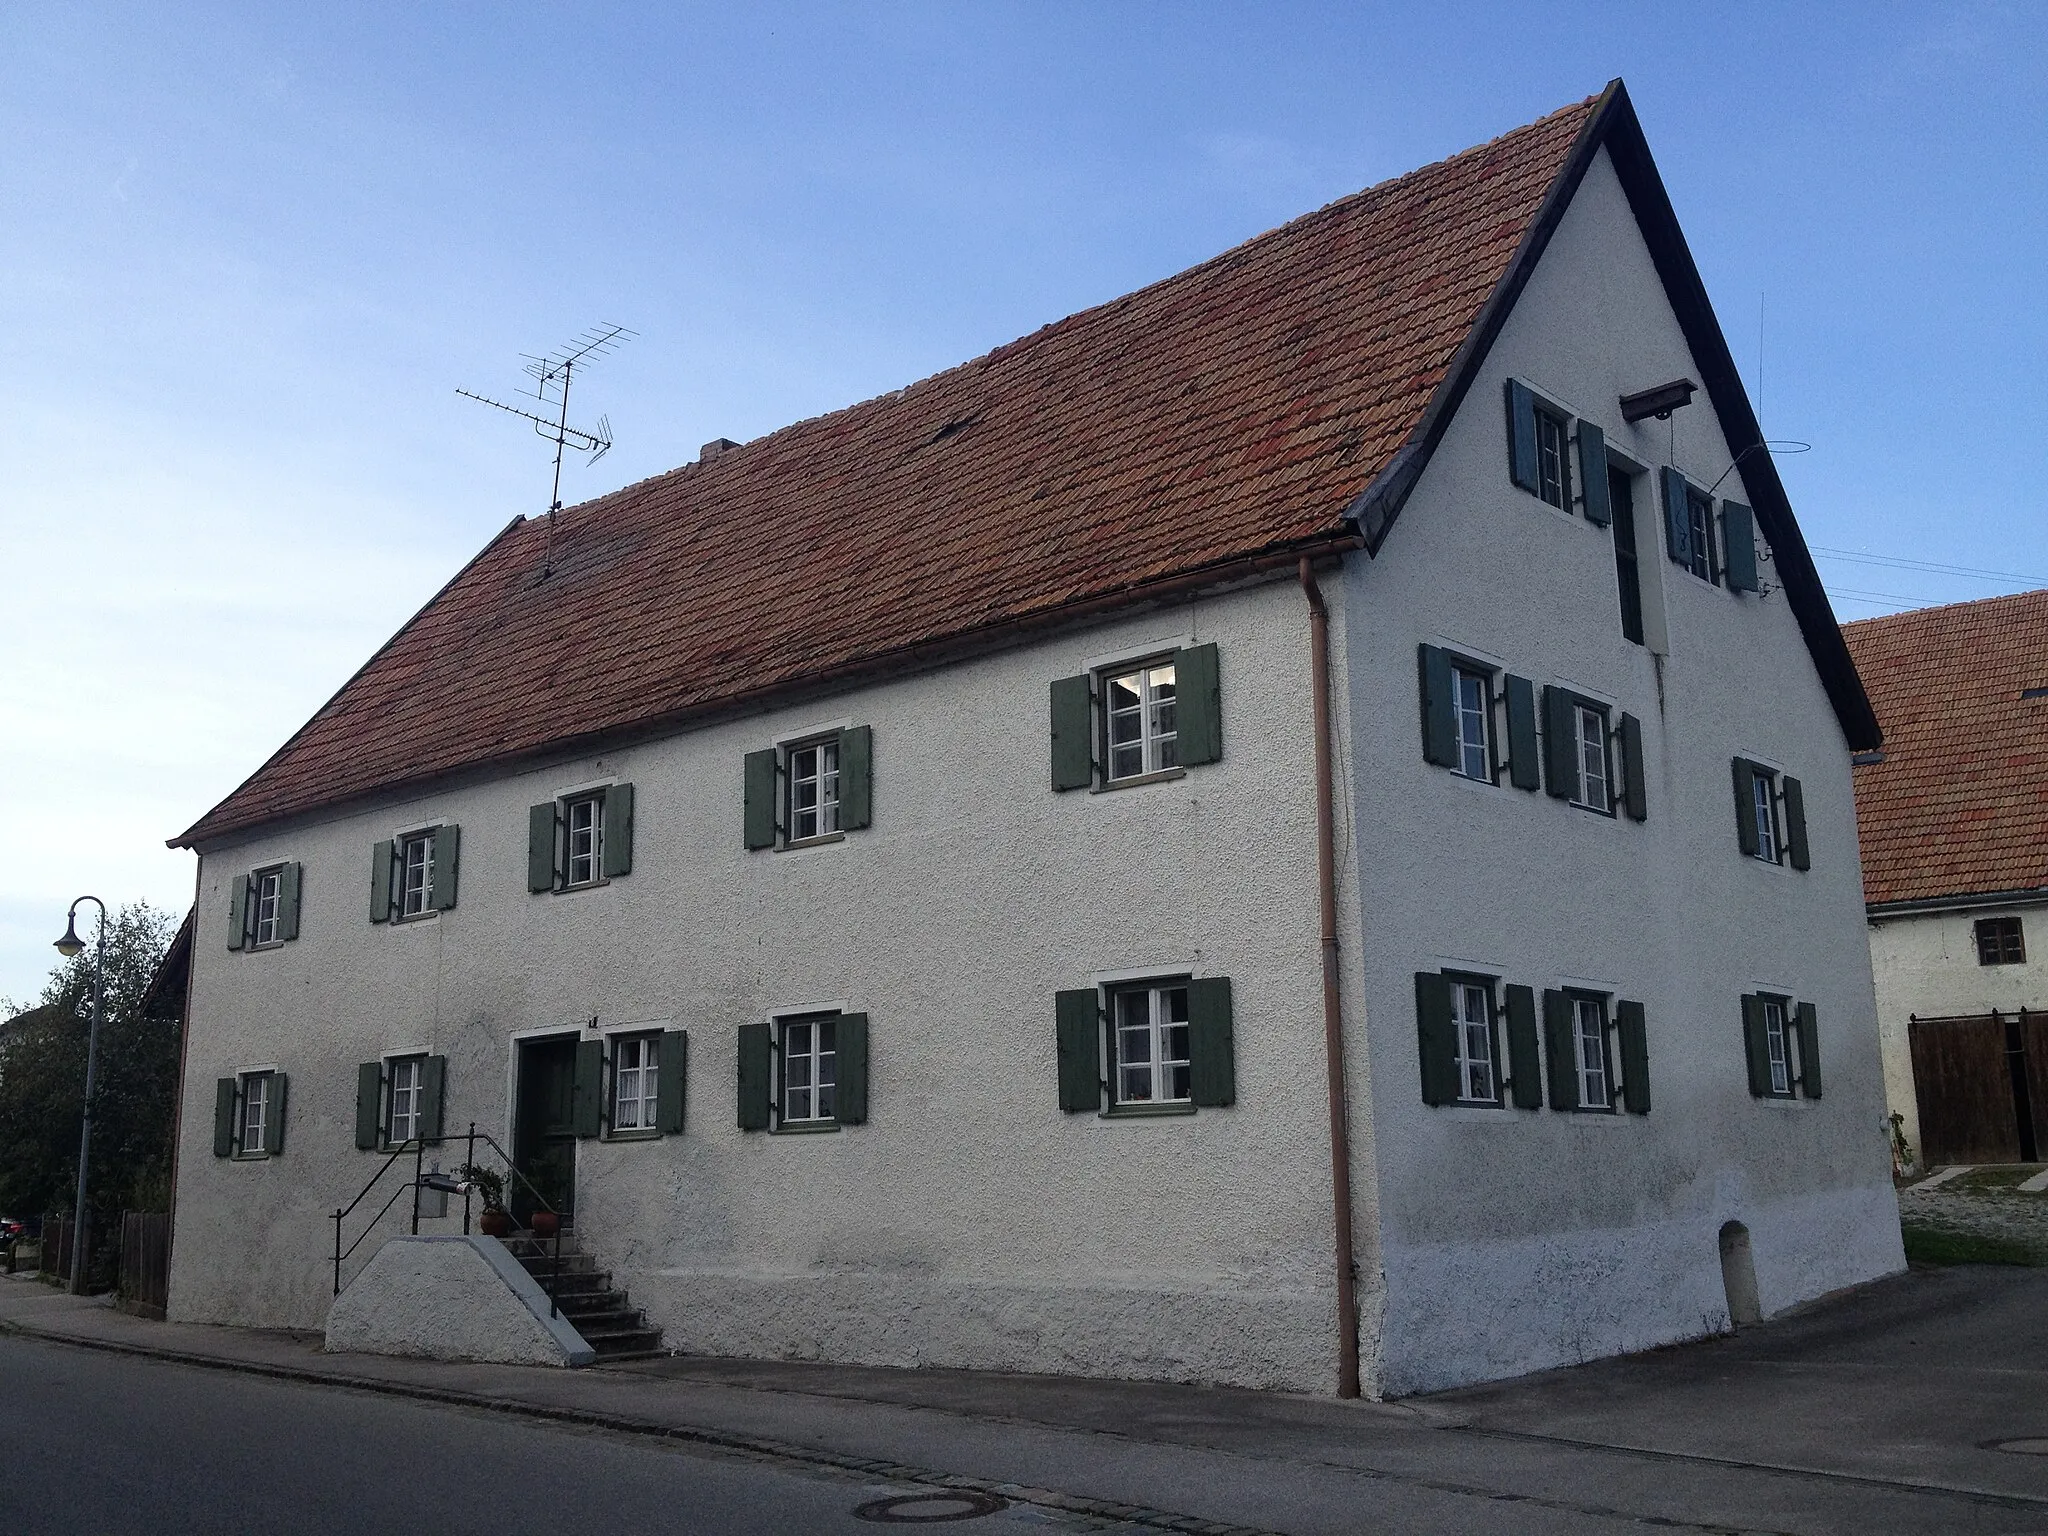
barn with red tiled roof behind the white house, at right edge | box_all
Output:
[1843,592,2048,1167]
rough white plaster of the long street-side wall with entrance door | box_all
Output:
[170,584,1370,1391]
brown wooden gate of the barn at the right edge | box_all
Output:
[1907,1008,2048,1167]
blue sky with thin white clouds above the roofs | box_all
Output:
[0,0,2048,997]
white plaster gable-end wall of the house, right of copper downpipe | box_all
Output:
[1346,154,1905,1395]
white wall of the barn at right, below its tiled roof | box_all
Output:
[1870,903,2048,1155]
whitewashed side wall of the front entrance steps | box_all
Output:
[326,1237,596,1366]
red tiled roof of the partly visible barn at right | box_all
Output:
[1841,592,2048,905]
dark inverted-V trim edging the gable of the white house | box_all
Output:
[1348,80,1884,752]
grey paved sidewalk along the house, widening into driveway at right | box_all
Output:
[0,1268,2048,1532]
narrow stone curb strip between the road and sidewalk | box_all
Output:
[0,1319,1282,1536]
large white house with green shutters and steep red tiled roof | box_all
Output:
[170,82,1903,1393]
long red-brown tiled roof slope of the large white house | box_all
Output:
[176,98,1599,846]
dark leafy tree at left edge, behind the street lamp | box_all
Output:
[0,901,180,1276]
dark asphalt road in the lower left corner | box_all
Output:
[0,1337,1087,1536]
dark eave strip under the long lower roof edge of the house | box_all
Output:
[170,532,1364,860]
